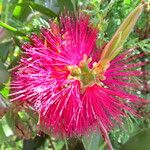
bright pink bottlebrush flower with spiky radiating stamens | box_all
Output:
[11,15,148,146]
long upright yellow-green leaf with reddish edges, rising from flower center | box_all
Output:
[101,4,143,61]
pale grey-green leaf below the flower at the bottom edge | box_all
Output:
[82,133,102,150]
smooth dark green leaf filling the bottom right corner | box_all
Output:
[121,129,150,150]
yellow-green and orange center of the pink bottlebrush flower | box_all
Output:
[68,55,108,88]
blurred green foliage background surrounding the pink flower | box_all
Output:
[0,0,150,150]
